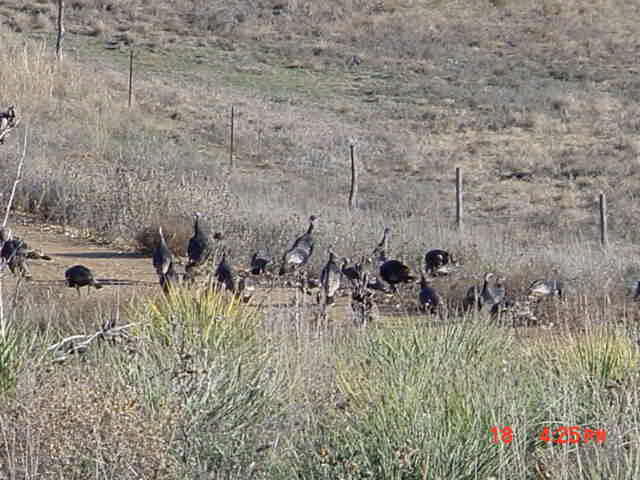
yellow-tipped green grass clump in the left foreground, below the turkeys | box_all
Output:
[127,289,282,478]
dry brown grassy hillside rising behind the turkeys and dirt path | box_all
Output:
[0,1,640,287]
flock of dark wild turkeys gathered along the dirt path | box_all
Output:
[0,213,563,326]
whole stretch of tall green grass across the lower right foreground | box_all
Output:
[276,321,638,479]
